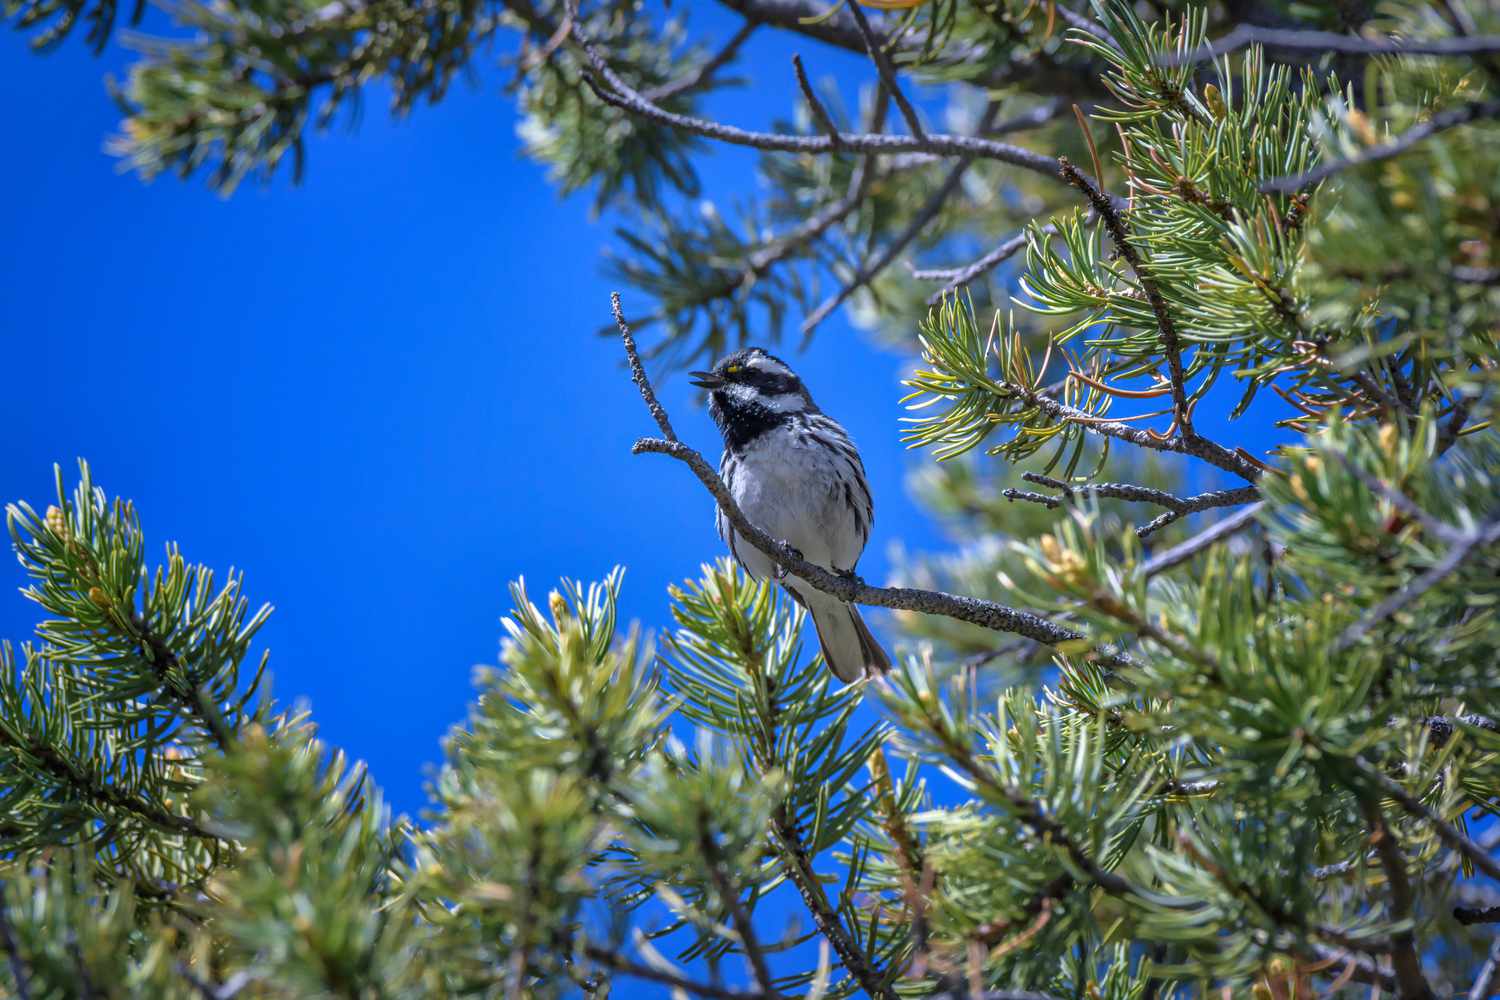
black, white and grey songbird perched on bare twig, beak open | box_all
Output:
[692,348,891,684]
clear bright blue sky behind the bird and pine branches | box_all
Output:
[0,9,939,813]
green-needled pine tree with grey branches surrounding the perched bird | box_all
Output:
[0,0,1500,1000]
